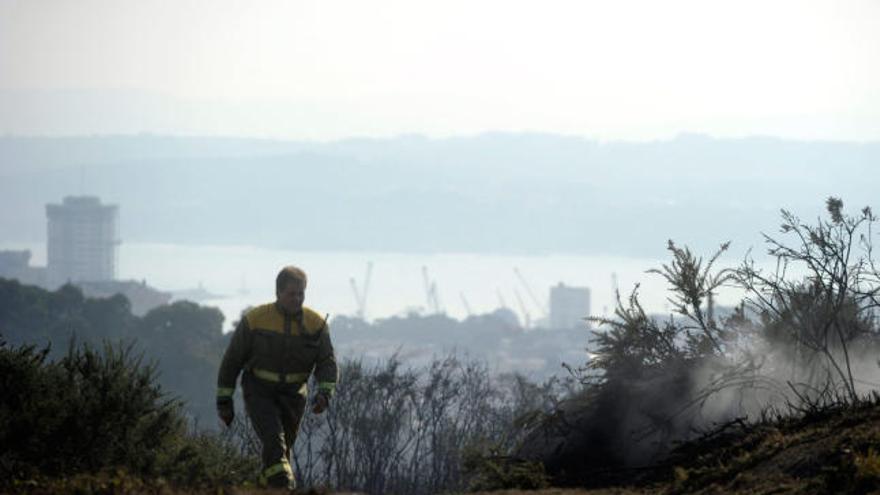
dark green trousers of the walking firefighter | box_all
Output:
[242,373,306,489]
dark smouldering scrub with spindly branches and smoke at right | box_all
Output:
[508,198,880,491]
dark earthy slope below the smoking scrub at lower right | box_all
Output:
[470,402,880,495]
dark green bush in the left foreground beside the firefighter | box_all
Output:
[0,340,257,486]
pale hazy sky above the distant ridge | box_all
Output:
[0,0,880,140]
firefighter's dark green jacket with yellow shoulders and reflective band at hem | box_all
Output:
[217,303,338,404]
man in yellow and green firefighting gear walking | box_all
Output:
[217,266,337,490]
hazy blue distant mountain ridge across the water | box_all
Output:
[0,133,880,256]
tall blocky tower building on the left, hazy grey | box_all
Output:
[46,196,119,287]
